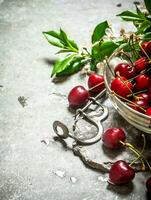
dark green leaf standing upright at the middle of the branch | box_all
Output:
[92,21,109,44]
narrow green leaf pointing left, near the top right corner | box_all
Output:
[117,10,144,22]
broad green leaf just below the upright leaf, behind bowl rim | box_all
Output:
[92,41,119,61]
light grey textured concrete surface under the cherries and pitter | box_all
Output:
[0,0,149,200]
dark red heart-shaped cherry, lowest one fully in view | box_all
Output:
[109,160,135,185]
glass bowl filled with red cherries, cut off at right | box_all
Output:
[104,41,151,133]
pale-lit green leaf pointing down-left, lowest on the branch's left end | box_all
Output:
[51,54,76,77]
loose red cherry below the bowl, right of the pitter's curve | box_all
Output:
[102,128,126,149]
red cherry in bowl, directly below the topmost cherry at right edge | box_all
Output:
[134,57,149,72]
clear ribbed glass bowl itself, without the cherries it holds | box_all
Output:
[104,53,151,134]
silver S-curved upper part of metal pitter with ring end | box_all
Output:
[53,89,108,145]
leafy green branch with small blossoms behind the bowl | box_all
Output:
[43,0,151,77]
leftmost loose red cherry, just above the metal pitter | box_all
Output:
[68,85,89,108]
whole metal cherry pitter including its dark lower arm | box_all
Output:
[53,89,108,171]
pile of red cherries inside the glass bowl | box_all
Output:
[111,42,151,116]
